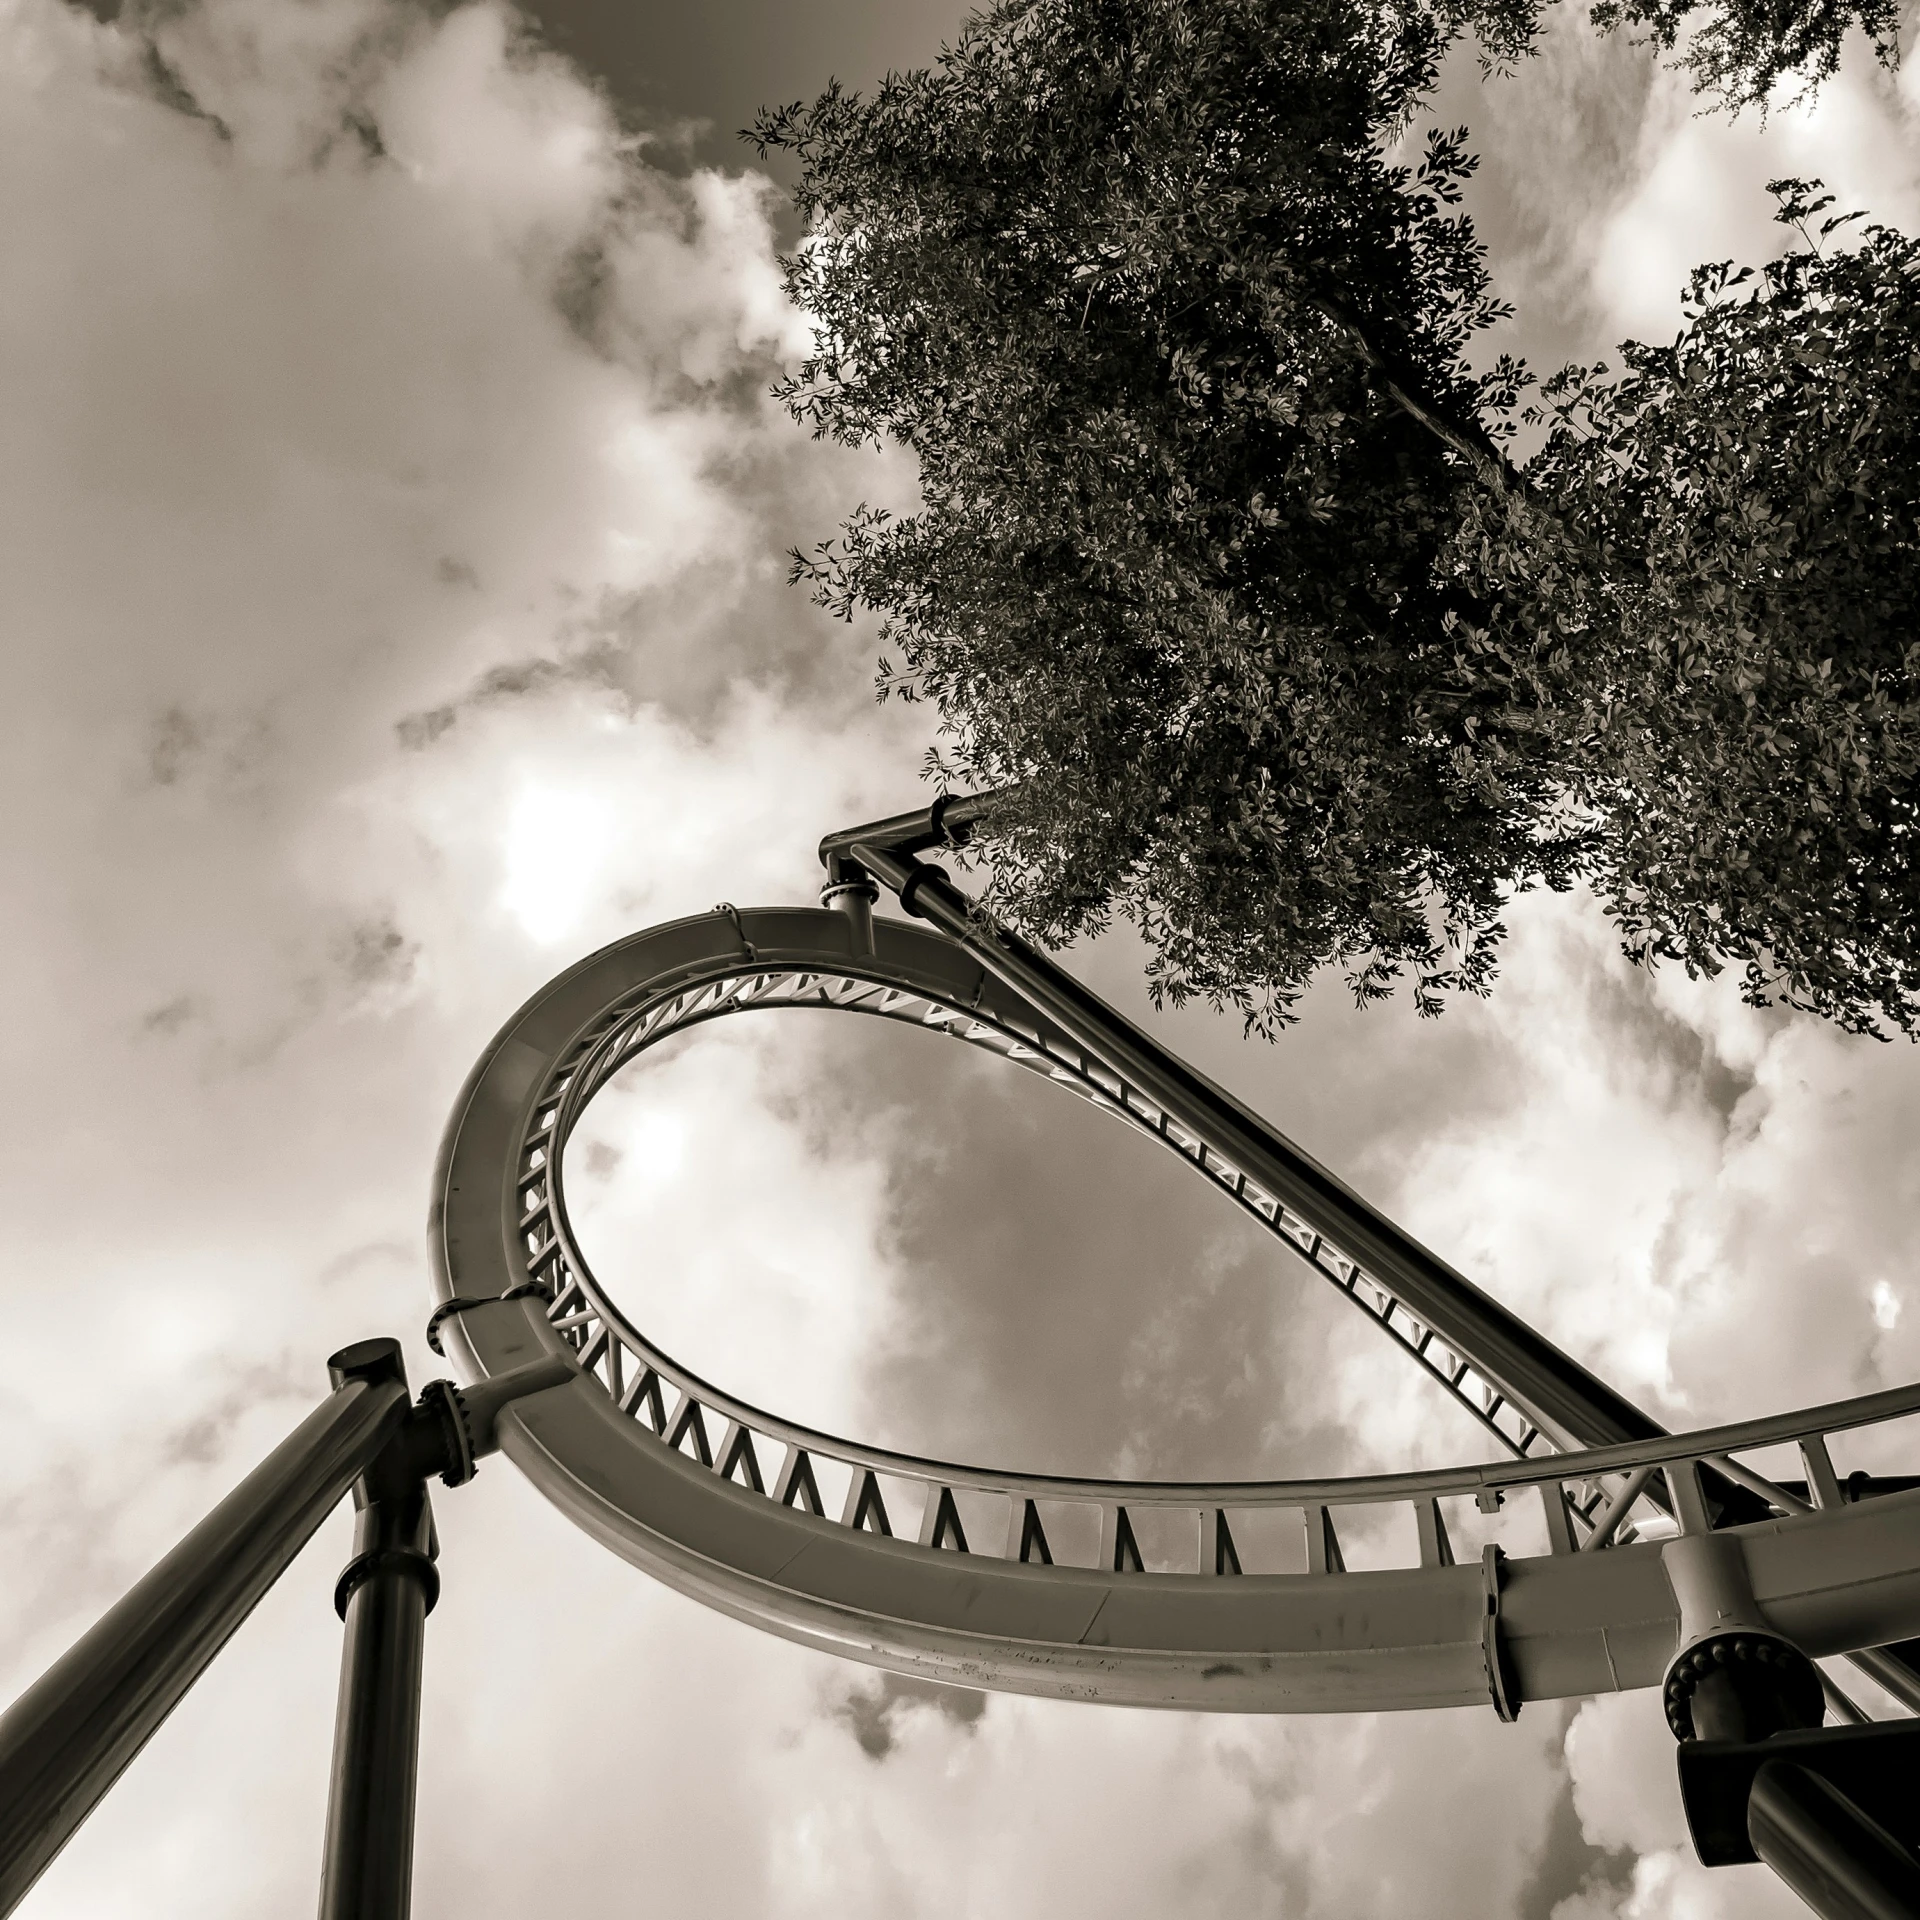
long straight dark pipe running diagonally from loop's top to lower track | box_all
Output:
[848,841,1663,1448]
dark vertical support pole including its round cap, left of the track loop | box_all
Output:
[321,1340,440,1920]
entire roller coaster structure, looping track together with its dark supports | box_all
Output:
[15,810,1920,1920]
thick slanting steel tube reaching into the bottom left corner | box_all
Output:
[0,1379,407,1914]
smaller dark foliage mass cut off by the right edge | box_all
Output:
[1503,180,1920,1033]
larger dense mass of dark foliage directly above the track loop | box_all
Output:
[760,0,1571,1020]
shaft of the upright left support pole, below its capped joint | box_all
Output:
[321,1492,430,1920]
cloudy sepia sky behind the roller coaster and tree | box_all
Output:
[11,0,1920,1920]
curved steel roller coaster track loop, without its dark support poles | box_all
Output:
[432,908,1920,1711]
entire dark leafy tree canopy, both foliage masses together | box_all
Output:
[758,0,1920,1031]
